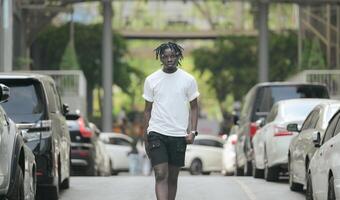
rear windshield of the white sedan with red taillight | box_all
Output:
[281,101,319,121]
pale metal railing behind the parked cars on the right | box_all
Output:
[287,70,340,99]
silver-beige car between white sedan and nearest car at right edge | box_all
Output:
[288,100,340,191]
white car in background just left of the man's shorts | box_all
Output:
[100,132,134,175]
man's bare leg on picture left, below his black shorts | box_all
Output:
[154,163,169,200]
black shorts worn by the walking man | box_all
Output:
[147,131,187,167]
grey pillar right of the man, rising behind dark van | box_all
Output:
[258,2,269,82]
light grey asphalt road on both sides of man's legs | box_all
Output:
[60,173,305,200]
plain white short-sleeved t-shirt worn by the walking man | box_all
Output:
[143,68,199,137]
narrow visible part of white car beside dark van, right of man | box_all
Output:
[222,134,237,175]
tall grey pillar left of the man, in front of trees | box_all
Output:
[102,0,113,132]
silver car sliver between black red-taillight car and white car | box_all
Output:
[89,122,112,176]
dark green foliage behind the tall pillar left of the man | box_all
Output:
[35,24,142,92]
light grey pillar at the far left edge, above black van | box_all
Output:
[0,0,13,72]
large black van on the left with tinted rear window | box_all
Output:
[0,73,71,199]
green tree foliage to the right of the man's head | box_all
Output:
[193,31,297,106]
